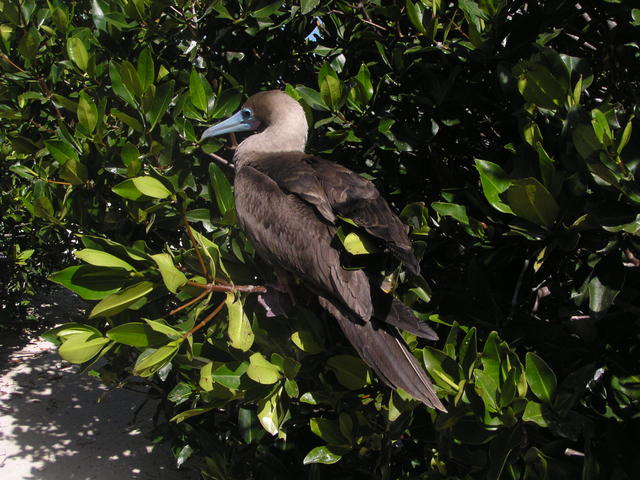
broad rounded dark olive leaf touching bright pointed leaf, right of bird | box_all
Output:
[504,177,560,228]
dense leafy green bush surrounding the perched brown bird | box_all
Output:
[0,0,640,479]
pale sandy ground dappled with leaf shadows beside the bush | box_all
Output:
[0,286,199,480]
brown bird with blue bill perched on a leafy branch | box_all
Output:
[202,90,446,411]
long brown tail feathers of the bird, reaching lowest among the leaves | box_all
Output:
[319,297,447,412]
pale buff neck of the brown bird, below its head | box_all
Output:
[234,122,307,168]
